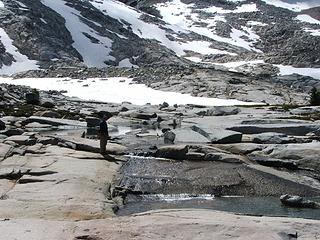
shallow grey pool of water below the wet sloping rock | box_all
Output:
[118,194,320,220]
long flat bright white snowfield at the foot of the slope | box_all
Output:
[0,78,256,106]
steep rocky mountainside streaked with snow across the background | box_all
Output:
[0,0,320,73]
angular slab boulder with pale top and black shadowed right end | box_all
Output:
[191,125,242,144]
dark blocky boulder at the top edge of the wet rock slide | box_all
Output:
[155,145,188,160]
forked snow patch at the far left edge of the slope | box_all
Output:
[0,28,39,75]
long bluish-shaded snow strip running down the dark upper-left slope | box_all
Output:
[41,0,115,67]
